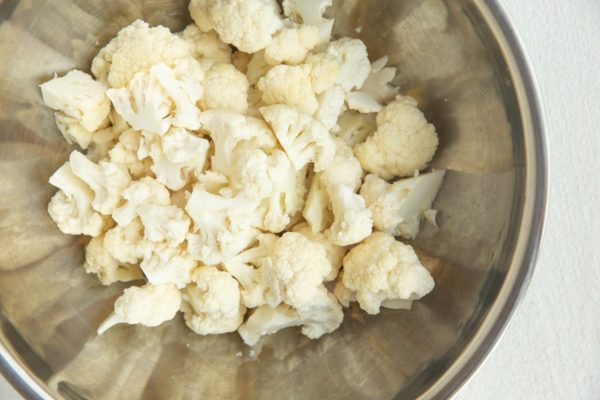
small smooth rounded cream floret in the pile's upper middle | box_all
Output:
[200,64,248,114]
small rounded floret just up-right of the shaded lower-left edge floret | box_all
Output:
[104,218,154,264]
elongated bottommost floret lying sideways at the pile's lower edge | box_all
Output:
[238,290,344,346]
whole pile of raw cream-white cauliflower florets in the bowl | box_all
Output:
[41,0,444,345]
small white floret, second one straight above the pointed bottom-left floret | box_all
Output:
[136,204,190,247]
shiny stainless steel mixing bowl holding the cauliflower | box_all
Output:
[0,0,546,400]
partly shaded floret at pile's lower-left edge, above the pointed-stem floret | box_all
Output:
[83,236,144,285]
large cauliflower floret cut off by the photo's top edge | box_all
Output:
[190,0,283,53]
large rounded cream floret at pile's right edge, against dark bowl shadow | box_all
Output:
[354,96,438,179]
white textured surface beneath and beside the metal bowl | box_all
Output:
[0,0,600,400]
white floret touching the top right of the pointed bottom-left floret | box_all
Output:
[140,243,198,289]
